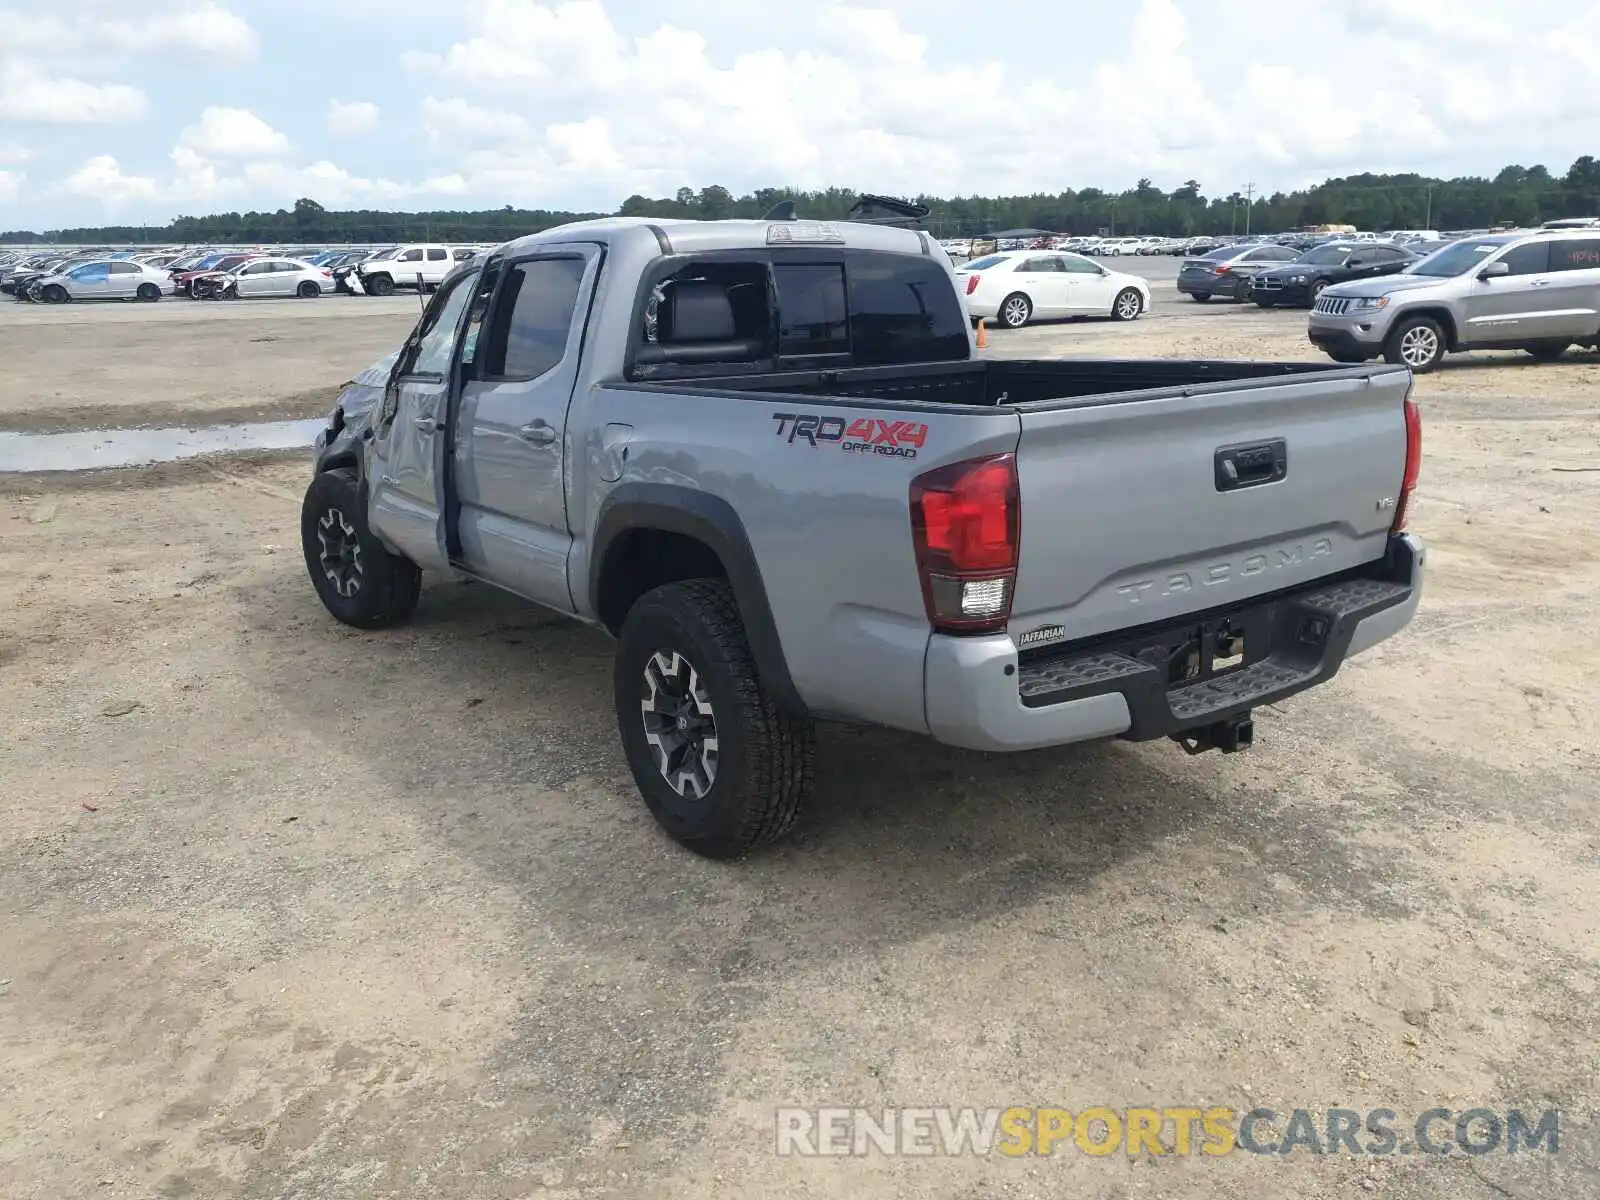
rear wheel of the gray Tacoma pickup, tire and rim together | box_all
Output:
[613,579,816,859]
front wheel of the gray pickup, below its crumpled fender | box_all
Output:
[301,467,422,629]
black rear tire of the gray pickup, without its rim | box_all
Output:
[613,579,816,859]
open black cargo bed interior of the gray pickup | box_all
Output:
[634,358,1363,408]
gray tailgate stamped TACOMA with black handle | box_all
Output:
[1008,368,1410,645]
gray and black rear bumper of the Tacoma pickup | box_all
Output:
[925,534,1424,750]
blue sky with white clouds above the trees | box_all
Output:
[0,0,1600,229]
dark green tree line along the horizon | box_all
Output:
[0,154,1600,245]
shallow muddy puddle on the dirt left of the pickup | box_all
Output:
[0,418,325,474]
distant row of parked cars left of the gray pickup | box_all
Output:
[0,243,483,304]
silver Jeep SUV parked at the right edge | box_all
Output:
[1307,229,1600,373]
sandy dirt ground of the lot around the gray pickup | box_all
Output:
[0,301,1600,1200]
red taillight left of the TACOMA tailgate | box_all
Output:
[910,454,1022,634]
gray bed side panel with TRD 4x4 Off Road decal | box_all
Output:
[568,386,1019,730]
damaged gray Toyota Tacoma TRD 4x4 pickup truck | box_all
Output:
[301,219,1422,858]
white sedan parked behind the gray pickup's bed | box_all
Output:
[955,250,1150,330]
